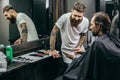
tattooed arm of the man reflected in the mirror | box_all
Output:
[20,23,28,43]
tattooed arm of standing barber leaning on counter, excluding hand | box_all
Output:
[50,25,59,51]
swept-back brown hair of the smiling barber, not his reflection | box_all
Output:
[72,2,86,12]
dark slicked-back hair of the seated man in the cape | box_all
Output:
[94,12,111,33]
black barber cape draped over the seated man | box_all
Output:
[56,33,120,80]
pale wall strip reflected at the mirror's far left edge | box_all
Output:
[0,0,9,45]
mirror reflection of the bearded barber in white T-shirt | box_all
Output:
[3,5,38,45]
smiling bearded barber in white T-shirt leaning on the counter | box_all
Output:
[50,2,89,64]
